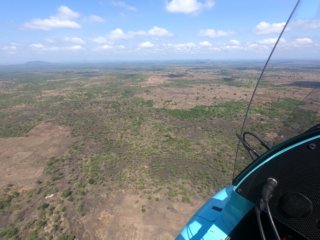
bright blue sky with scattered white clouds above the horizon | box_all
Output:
[0,0,320,64]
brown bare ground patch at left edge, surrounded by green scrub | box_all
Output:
[0,123,72,189]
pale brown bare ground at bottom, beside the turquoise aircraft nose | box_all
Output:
[82,190,203,240]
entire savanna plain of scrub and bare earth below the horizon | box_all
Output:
[0,61,320,240]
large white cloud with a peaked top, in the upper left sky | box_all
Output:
[23,6,81,31]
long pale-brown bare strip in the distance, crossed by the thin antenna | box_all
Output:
[140,84,310,109]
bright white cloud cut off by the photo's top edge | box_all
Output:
[166,0,214,14]
